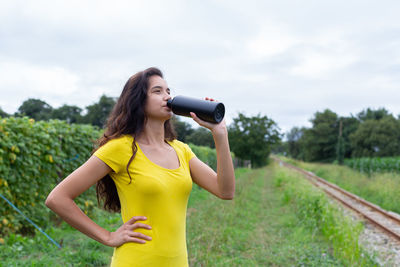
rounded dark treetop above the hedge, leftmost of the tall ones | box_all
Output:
[15,98,53,121]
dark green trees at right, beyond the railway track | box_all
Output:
[284,108,400,163]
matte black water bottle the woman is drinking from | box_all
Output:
[167,96,225,123]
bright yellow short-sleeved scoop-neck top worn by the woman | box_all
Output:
[94,135,195,267]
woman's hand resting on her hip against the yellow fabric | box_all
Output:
[105,216,151,247]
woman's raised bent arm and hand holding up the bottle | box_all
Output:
[189,105,235,199]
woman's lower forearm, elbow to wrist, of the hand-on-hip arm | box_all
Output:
[46,195,110,245]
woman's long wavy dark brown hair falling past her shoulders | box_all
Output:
[96,67,176,212]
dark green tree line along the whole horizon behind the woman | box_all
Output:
[0,95,400,167]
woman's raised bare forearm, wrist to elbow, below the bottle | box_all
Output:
[213,131,235,199]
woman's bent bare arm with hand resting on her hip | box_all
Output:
[46,156,150,247]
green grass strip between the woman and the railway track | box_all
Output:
[188,167,374,266]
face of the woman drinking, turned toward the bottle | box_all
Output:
[144,75,172,121]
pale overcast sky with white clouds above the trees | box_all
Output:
[0,0,400,132]
